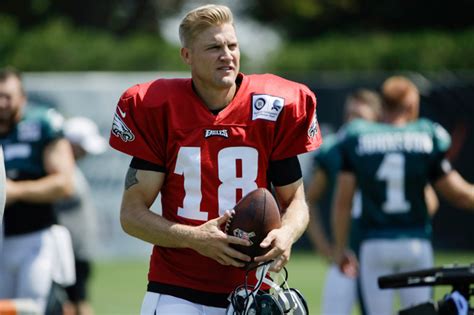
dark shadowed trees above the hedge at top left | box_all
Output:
[0,0,181,36]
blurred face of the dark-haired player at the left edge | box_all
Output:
[0,77,26,134]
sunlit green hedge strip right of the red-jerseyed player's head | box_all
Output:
[268,28,474,72]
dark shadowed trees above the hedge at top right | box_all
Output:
[248,0,474,39]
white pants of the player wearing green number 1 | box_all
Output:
[360,239,433,315]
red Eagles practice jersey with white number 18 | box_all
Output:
[110,74,322,293]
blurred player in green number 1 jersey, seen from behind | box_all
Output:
[332,76,474,315]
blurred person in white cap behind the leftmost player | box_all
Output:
[56,117,107,315]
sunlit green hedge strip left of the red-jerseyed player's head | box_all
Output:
[0,17,185,71]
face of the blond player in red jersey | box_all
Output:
[182,24,240,89]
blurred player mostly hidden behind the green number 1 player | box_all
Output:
[307,89,381,315]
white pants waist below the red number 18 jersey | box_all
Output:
[140,292,226,315]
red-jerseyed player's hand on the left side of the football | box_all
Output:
[191,210,251,267]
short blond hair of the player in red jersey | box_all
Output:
[179,4,234,47]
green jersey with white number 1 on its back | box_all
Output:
[340,119,451,238]
